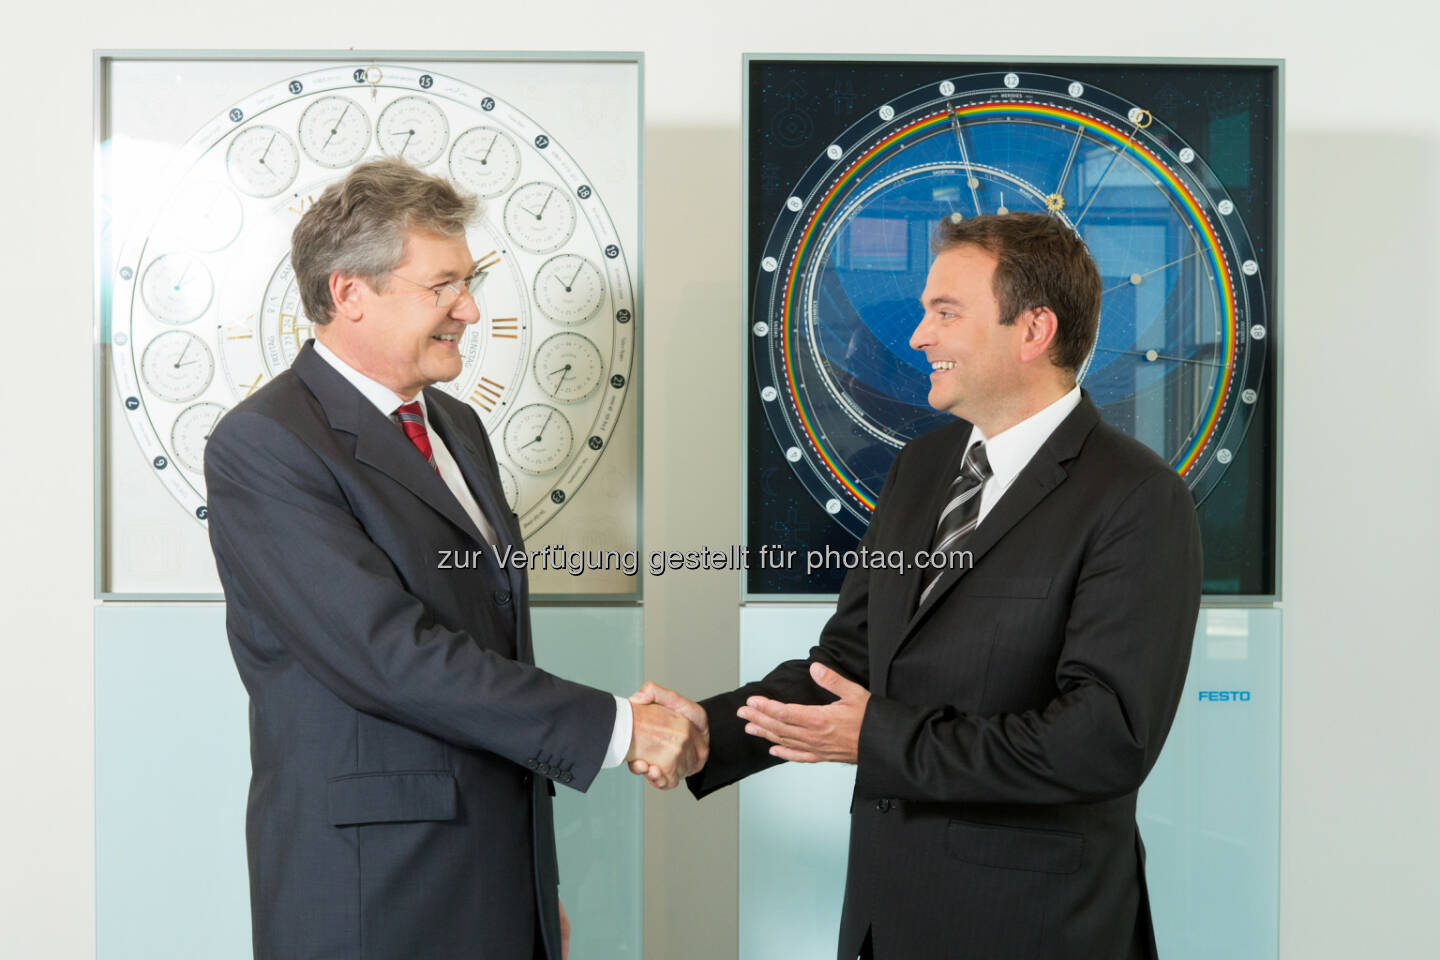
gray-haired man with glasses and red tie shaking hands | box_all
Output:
[204,160,696,960]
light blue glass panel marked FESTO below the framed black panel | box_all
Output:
[739,604,1280,960]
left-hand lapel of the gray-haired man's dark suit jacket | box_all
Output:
[291,341,485,545]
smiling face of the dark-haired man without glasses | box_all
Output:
[910,243,1028,435]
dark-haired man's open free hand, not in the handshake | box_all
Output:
[734,664,870,763]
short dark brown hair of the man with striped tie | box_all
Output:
[930,213,1100,373]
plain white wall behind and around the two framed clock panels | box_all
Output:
[0,0,1440,960]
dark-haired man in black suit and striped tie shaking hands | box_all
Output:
[632,213,1201,960]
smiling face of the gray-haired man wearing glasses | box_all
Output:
[317,230,480,400]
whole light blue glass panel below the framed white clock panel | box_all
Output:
[95,604,641,960]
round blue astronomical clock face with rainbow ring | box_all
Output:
[750,72,1269,535]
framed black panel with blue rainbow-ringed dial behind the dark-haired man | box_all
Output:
[744,56,1280,600]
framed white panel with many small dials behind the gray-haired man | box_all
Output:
[95,52,642,599]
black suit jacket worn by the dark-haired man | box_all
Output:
[690,397,1201,960]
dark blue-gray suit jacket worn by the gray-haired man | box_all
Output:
[204,344,615,960]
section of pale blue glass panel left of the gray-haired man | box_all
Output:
[95,603,251,960]
